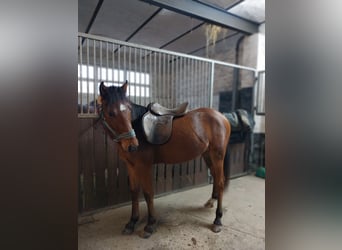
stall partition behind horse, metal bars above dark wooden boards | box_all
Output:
[78,33,256,212]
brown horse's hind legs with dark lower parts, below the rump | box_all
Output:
[203,151,224,233]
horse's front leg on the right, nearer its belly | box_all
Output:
[141,165,157,238]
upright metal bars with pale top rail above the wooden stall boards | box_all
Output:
[78,33,255,118]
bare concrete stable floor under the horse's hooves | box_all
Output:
[78,175,265,250]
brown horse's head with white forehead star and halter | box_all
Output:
[98,81,139,152]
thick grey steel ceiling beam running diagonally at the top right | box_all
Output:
[140,0,258,34]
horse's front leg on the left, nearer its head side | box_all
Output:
[122,168,140,234]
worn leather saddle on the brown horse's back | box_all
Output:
[142,102,188,145]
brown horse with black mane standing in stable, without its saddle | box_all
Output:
[98,81,231,238]
